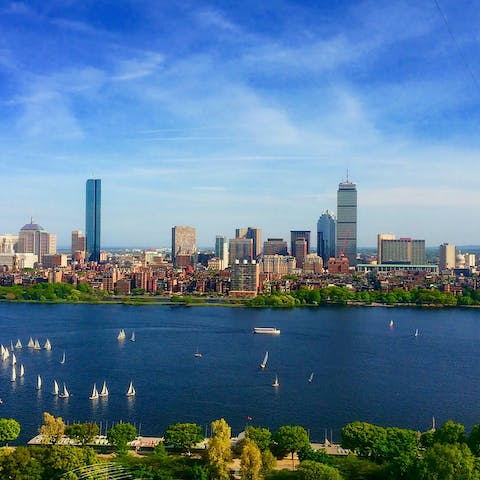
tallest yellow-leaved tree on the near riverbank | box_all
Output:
[206,418,232,480]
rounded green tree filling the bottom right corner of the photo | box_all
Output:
[418,443,478,480]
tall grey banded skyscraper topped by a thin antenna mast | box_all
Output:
[336,177,357,266]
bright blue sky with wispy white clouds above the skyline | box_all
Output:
[0,0,480,247]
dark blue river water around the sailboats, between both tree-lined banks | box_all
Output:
[0,304,480,441]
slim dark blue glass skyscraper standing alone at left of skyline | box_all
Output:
[85,178,102,262]
